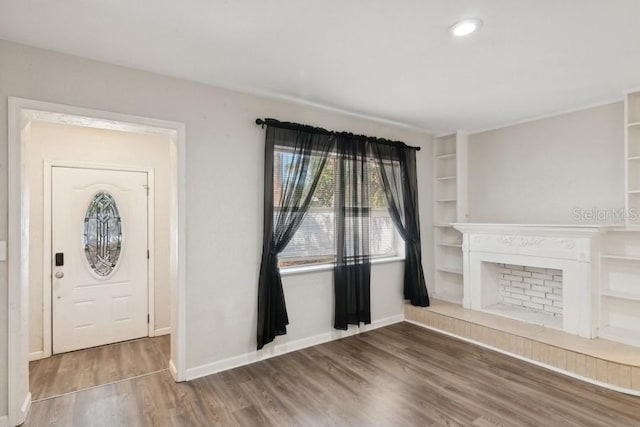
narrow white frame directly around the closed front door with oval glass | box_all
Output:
[43,159,155,360]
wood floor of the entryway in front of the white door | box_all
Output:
[29,335,171,401]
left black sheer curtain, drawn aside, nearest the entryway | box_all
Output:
[257,126,334,350]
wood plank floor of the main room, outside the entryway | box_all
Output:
[26,323,640,427]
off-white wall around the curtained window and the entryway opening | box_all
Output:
[0,37,432,414]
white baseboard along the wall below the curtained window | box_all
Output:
[186,314,404,381]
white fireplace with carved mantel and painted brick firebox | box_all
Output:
[454,223,600,338]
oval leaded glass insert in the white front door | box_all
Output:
[84,192,122,276]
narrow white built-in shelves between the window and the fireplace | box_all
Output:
[431,132,468,304]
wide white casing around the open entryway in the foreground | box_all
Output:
[7,97,186,425]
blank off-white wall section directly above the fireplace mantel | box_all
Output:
[469,103,624,224]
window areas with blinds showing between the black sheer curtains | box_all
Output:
[273,147,402,267]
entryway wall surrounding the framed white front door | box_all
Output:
[24,121,170,353]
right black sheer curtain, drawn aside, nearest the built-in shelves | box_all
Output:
[370,143,429,307]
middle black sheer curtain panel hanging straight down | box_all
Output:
[333,135,371,330]
